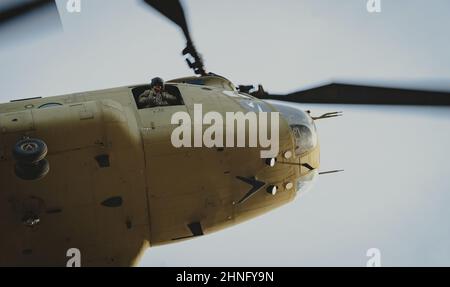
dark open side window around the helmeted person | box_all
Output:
[131,84,184,109]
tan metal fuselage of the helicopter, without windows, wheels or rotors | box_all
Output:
[0,78,319,266]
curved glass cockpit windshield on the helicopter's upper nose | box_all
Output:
[270,102,317,155]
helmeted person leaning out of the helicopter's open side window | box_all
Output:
[138,77,177,109]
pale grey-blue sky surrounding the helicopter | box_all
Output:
[0,0,450,266]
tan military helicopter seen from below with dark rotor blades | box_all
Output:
[0,0,450,266]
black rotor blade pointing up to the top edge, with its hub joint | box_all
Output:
[144,0,206,75]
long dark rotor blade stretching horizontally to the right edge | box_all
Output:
[251,83,450,106]
